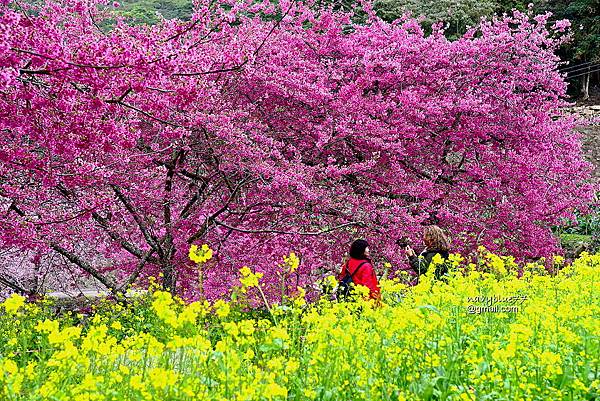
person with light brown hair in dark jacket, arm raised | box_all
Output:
[406,226,450,280]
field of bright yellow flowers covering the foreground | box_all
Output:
[0,248,600,401]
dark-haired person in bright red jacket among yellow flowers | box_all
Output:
[338,239,381,299]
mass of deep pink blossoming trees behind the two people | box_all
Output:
[0,0,593,297]
